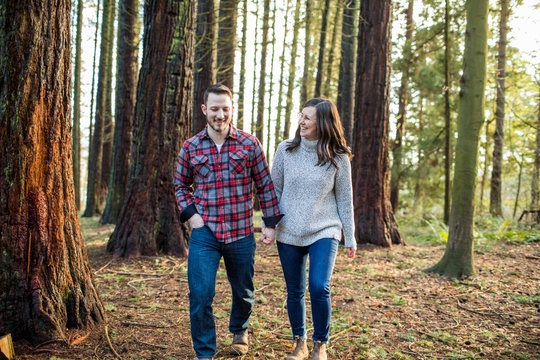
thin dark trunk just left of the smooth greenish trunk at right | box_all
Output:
[443,0,452,225]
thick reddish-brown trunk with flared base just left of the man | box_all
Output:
[107,0,196,257]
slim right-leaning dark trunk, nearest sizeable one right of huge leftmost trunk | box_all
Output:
[83,0,114,217]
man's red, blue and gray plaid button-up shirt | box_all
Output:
[174,125,283,244]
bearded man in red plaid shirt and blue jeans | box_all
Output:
[174,84,283,360]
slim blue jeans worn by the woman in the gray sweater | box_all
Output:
[277,238,339,343]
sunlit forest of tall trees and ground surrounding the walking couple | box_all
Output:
[0,0,540,360]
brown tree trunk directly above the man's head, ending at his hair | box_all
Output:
[216,0,238,90]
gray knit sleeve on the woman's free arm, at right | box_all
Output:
[335,156,356,249]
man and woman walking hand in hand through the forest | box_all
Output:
[174,84,356,360]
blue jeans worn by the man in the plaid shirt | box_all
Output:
[188,226,256,358]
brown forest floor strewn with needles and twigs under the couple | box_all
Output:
[15,218,540,360]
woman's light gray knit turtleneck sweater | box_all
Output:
[272,138,356,249]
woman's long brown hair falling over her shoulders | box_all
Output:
[287,97,352,168]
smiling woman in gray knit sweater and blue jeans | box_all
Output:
[263,98,356,360]
